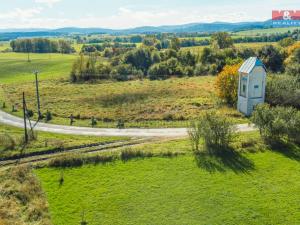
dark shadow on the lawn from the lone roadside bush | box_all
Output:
[195,149,255,173]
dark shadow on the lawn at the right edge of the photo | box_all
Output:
[269,141,300,161]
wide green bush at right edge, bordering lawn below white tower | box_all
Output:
[251,104,300,143]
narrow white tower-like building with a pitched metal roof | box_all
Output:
[237,57,267,116]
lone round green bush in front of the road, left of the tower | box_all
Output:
[189,111,235,150]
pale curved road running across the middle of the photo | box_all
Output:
[0,110,255,137]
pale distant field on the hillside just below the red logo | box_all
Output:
[234,27,299,36]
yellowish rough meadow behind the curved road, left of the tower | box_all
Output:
[0,76,247,127]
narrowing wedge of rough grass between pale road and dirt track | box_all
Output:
[0,124,127,158]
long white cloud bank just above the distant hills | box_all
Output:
[0,0,292,29]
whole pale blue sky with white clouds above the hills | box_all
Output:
[0,0,300,29]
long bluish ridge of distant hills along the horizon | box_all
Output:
[0,20,288,40]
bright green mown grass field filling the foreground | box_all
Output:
[35,134,300,225]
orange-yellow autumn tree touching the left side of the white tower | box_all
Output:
[216,64,240,105]
